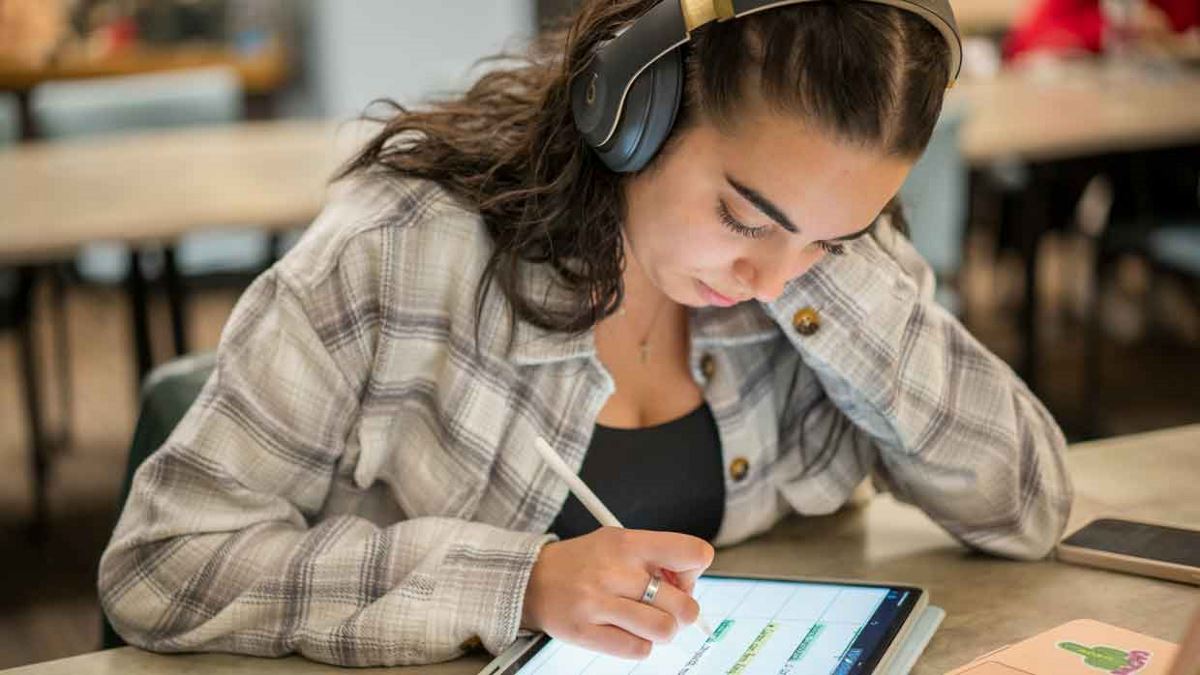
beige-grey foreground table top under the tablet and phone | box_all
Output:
[5,424,1200,675]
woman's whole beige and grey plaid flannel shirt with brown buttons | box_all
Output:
[100,170,1072,665]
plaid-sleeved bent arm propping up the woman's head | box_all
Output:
[770,225,1072,557]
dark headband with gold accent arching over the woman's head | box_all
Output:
[571,0,962,148]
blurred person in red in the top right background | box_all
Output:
[1004,0,1200,60]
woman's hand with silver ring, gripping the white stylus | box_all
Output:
[521,527,713,658]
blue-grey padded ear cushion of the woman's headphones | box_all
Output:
[595,48,683,173]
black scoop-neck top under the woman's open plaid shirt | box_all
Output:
[550,404,725,540]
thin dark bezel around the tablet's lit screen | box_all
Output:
[479,572,929,675]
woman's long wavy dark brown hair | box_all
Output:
[338,0,949,335]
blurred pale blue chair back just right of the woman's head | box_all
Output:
[900,104,970,318]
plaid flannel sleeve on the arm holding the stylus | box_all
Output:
[98,206,550,665]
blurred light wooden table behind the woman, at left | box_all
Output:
[0,120,366,263]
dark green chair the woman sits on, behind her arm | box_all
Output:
[101,353,216,649]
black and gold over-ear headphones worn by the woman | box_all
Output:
[571,0,962,173]
